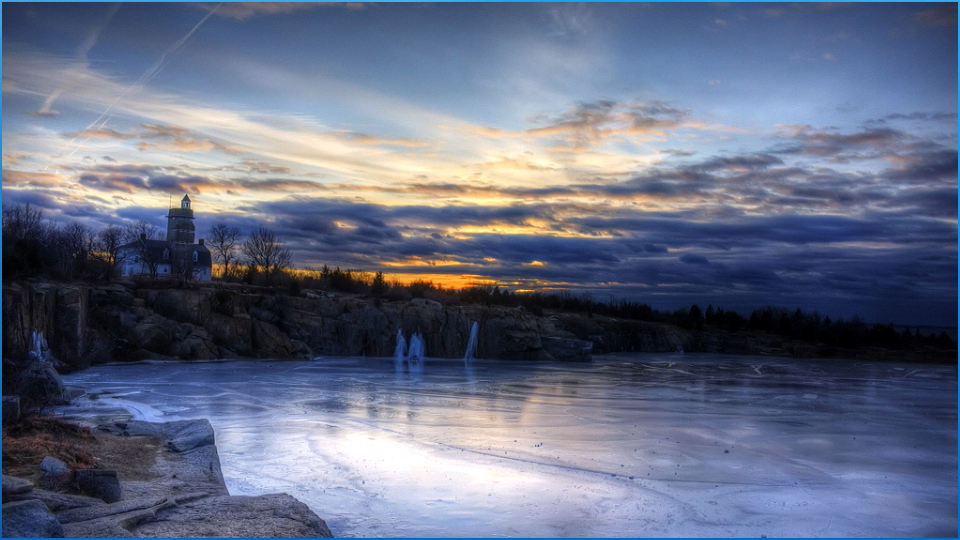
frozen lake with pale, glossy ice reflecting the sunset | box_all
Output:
[65,354,957,537]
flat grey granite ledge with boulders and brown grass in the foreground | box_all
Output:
[3,420,333,538]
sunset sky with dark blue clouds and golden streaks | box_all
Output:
[2,3,958,326]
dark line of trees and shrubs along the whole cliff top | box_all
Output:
[3,204,957,350]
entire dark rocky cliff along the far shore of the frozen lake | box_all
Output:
[3,282,944,370]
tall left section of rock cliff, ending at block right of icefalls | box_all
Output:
[3,284,600,369]
